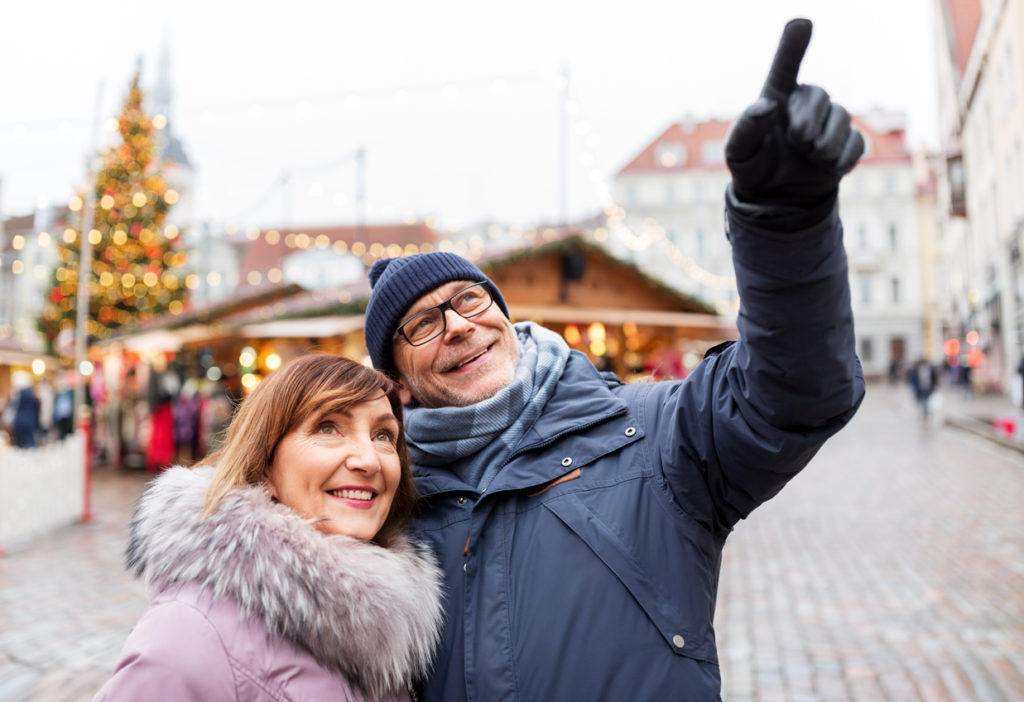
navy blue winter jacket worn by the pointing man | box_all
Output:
[407,203,863,702]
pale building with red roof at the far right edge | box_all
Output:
[933,0,1024,390]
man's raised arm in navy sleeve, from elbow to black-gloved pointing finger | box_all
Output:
[659,19,864,527]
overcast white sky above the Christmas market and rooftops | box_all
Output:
[0,0,938,233]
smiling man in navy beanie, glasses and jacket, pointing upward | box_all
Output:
[366,20,863,702]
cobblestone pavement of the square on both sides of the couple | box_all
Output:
[0,385,1024,702]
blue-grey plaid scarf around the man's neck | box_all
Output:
[406,321,569,490]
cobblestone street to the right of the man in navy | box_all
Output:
[717,386,1024,702]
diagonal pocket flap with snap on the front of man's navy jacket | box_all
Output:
[545,493,718,665]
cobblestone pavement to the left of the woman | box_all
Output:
[0,467,152,702]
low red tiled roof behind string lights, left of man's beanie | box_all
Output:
[239,222,440,279]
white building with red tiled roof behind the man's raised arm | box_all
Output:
[605,113,926,376]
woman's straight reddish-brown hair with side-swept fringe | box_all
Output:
[201,353,417,546]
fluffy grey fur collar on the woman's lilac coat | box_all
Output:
[127,467,441,697]
